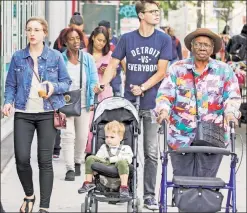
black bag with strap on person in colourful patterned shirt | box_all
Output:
[192,71,226,148]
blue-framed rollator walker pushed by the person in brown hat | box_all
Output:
[159,122,238,212]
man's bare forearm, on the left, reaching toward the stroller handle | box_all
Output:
[100,58,120,85]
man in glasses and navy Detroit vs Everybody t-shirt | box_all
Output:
[94,0,172,210]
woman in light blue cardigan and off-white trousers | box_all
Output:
[61,27,99,181]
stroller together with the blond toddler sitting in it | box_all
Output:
[78,95,141,212]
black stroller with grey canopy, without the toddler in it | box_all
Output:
[81,95,141,212]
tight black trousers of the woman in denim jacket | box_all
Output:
[14,112,56,208]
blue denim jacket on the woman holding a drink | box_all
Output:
[4,44,72,111]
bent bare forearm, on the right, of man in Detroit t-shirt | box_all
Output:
[142,59,168,91]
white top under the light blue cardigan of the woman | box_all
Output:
[67,61,87,107]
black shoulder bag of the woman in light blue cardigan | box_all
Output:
[60,51,83,116]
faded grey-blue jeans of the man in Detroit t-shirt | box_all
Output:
[139,110,159,199]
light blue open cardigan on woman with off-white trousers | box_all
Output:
[62,50,99,111]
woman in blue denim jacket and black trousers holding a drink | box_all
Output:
[3,17,71,212]
